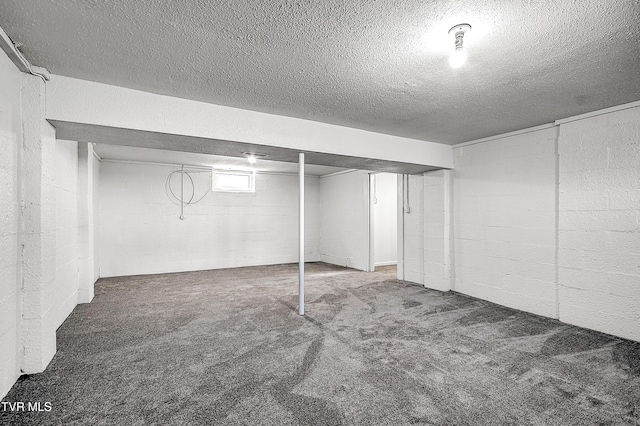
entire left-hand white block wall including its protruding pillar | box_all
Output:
[0,47,95,398]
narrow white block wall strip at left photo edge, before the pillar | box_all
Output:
[0,40,22,398]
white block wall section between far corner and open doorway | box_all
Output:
[319,170,369,271]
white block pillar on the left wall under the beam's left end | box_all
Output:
[19,74,57,380]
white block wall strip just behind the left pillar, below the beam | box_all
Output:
[49,140,79,329]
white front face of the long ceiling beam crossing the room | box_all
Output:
[46,75,453,170]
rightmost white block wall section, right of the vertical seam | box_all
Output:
[558,108,640,341]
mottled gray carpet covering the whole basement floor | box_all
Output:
[0,263,640,425]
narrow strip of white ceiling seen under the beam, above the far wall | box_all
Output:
[94,144,345,176]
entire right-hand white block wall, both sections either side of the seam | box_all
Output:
[453,106,640,341]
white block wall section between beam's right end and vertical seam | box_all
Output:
[453,128,557,317]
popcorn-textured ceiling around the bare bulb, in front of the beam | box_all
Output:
[0,0,640,143]
